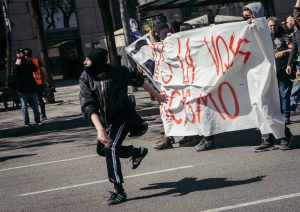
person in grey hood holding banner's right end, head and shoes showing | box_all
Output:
[243,0,294,152]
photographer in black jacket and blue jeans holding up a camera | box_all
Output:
[14,49,41,127]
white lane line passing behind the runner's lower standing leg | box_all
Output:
[17,165,194,196]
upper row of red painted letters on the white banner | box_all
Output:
[152,34,251,85]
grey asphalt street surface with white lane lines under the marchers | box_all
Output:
[0,81,300,212]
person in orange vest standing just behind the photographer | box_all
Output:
[24,48,48,120]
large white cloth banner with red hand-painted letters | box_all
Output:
[126,18,284,138]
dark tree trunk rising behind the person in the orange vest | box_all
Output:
[31,0,53,84]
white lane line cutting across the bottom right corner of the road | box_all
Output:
[202,193,300,212]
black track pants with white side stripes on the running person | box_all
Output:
[97,123,140,183]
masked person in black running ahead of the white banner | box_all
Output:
[79,48,165,205]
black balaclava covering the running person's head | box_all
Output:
[84,48,107,77]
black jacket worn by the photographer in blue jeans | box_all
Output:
[14,60,38,93]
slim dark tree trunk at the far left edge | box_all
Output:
[0,0,13,86]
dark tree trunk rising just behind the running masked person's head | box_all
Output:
[98,0,120,65]
